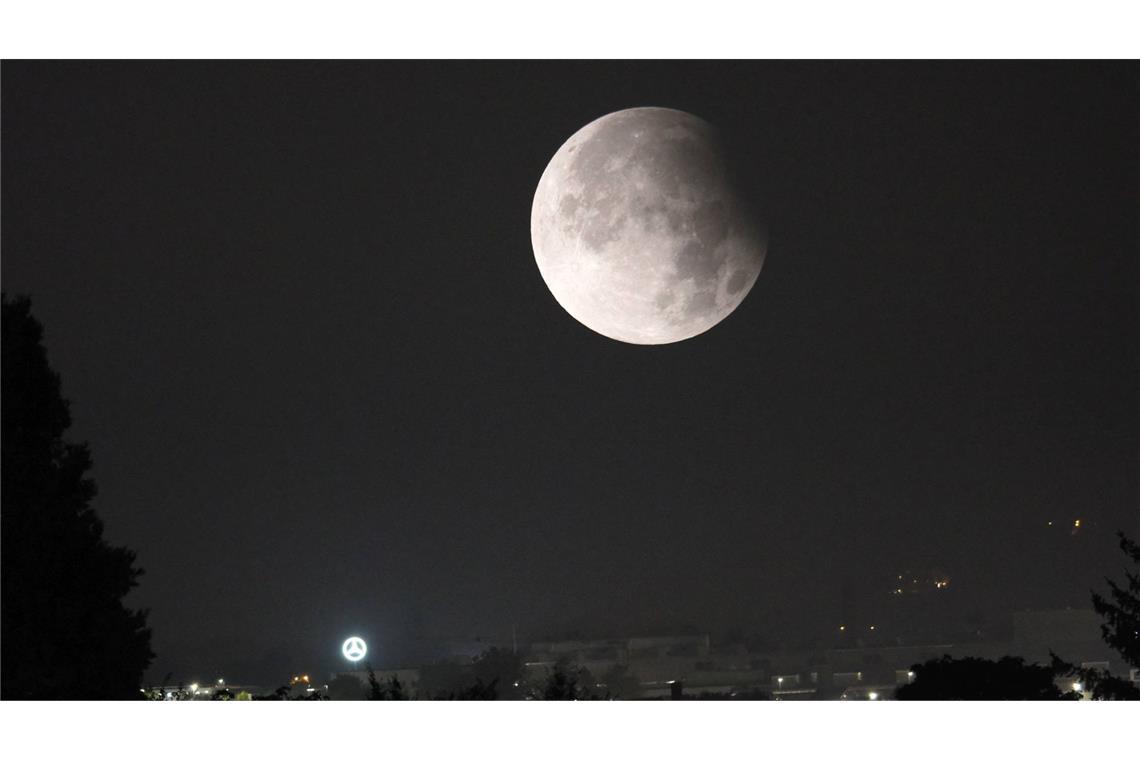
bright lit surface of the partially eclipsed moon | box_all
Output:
[530,108,766,344]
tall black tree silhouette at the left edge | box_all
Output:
[0,294,154,700]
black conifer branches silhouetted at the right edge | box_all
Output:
[1049,532,1140,700]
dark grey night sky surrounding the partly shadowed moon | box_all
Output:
[2,62,1140,683]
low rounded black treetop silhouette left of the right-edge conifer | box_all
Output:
[895,655,1074,700]
